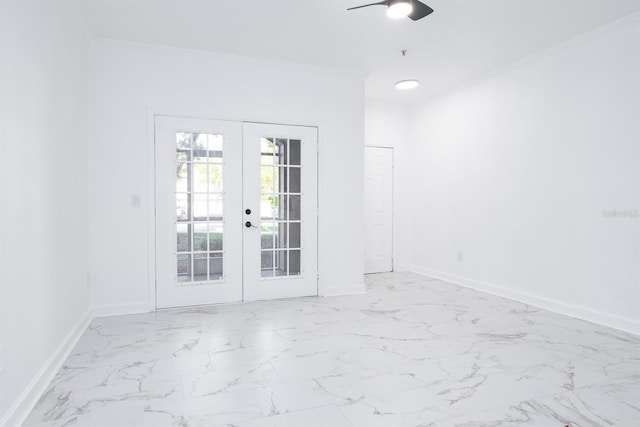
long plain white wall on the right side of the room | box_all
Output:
[411,16,640,332]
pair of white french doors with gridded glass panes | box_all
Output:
[155,116,317,308]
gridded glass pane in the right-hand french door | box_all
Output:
[260,137,303,279]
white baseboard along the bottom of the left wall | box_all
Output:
[0,310,93,427]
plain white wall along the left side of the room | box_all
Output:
[0,1,89,426]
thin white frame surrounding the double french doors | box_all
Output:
[146,108,323,313]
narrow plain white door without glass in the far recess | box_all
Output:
[364,147,393,273]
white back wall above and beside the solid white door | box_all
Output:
[364,100,415,271]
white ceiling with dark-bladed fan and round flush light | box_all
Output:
[76,0,640,102]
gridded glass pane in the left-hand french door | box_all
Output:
[174,131,224,285]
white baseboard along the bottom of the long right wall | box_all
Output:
[409,265,640,335]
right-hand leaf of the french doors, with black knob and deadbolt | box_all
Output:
[243,123,318,300]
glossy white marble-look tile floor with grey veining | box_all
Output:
[25,273,640,427]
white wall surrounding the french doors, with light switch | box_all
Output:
[89,41,364,313]
